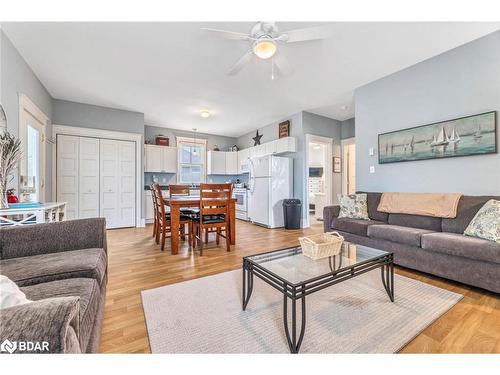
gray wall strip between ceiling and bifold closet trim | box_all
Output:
[52,99,144,134]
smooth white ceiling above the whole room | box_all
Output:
[2,22,500,136]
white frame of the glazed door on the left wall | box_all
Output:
[17,94,50,202]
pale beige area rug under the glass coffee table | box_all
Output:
[142,270,463,353]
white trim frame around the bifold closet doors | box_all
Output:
[52,125,146,227]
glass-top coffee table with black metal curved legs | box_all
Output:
[243,242,394,353]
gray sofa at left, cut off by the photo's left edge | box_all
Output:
[0,218,108,353]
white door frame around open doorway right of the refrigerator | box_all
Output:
[302,134,334,228]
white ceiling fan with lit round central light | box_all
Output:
[201,22,330,79]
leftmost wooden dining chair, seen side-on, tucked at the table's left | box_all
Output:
[153,184,193,251]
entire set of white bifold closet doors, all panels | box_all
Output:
[56,135,136,228]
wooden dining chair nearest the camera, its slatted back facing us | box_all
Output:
[192,184,233,256]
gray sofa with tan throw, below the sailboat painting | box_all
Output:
[323,193,500,293]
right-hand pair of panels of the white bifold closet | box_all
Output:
[100,139,136,228]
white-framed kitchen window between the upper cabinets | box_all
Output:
[177,137,207,184]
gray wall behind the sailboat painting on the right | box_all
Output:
[355,31,500,195]
